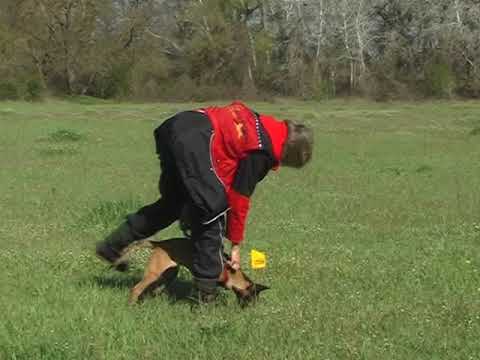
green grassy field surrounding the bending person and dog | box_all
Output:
[0,99,480,360]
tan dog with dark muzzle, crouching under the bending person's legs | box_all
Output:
[122,237,268,307]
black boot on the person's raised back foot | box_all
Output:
[95,221,145,271]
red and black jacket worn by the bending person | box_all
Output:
[199,101,288,244]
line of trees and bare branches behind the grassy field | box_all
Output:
[0,0,480,100]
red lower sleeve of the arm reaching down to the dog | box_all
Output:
[227,188,250,244]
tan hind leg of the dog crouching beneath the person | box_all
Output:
[129,247,178,304]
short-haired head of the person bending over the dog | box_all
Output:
[280,120,313,168]
